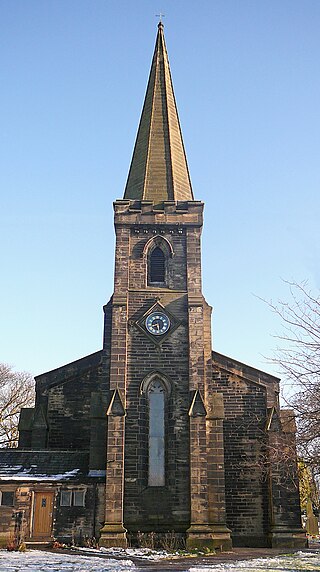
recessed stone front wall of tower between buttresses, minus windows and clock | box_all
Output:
[124,222,190,531]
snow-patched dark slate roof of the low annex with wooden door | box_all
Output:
[0,449,89,481]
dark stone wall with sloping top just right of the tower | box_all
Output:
[213,367,269,546]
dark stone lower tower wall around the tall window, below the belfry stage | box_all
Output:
[125,294,190,530]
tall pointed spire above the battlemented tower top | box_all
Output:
[124,22,193,205]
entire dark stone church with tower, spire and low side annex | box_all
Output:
[0,22,305,550]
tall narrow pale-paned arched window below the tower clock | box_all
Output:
[148,378,166,487]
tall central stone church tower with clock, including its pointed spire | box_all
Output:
[100,22,231,549]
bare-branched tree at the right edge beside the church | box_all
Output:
[269,282,320,475]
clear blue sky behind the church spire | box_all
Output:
[0,0,320,380]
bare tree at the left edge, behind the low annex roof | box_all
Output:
[0,364,34,448]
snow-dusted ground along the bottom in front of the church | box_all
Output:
[0,550,320,572]
